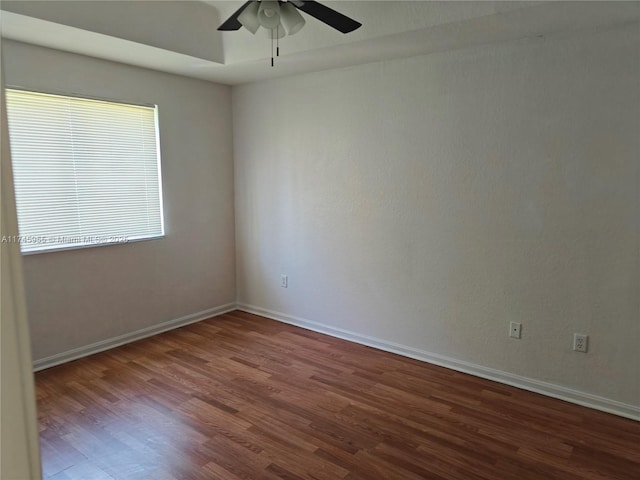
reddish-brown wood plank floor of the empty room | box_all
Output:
[36,312,640,480]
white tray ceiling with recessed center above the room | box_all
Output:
[0,0,640,85]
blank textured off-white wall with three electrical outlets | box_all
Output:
[233,24,640,414]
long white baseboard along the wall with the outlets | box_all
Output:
[237,303,640,421]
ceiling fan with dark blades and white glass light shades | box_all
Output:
[218,0,362,38]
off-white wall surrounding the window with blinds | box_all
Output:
[2,41,235,363]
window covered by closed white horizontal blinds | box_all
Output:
[3,89,164,253]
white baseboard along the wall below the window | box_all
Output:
[33,303,236,372]
